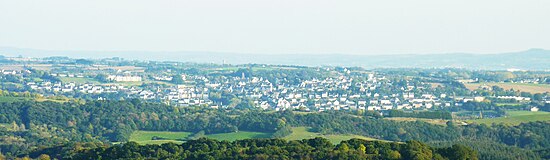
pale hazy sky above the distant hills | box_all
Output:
[0,0,550,54]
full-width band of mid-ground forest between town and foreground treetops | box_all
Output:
[0,99,550,159]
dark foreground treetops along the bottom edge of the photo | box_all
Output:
[33,138,477,160]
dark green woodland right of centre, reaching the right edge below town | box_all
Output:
[281,112,550,149]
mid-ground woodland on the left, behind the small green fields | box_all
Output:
[0,99,291,155]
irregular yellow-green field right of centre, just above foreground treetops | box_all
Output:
[284,127,378,144]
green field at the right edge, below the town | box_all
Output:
[468,111,550,125]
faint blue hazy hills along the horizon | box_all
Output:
[0,47,550,70]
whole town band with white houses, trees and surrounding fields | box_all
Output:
[0,57,550,116]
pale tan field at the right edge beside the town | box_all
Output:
[464,83,550,93]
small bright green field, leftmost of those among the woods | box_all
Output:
[130,131,192,144]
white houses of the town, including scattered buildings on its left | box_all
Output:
[7,66,548,111]
